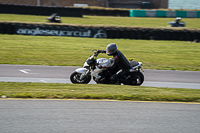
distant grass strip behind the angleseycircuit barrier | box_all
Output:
[0,14,200,28]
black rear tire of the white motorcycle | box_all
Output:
[128,71,144,86]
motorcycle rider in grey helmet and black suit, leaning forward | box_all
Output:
[97,43,130,84]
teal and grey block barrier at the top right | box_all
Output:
[130,10,200,18]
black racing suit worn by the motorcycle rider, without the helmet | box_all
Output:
[98,50,130,83]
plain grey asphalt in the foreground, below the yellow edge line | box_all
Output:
[0,99,200,133]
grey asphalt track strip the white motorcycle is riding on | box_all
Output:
[0,64,200,89]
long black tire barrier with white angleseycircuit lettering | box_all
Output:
[0,22,200,41]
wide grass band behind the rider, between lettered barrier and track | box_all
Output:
[0,35,200,71]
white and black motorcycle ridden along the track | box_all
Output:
[70,50,144,86]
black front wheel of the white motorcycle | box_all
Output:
[70,72,91,84]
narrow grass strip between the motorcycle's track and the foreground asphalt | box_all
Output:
[0,82,200,102]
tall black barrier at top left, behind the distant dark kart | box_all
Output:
[0,4,83,17]
